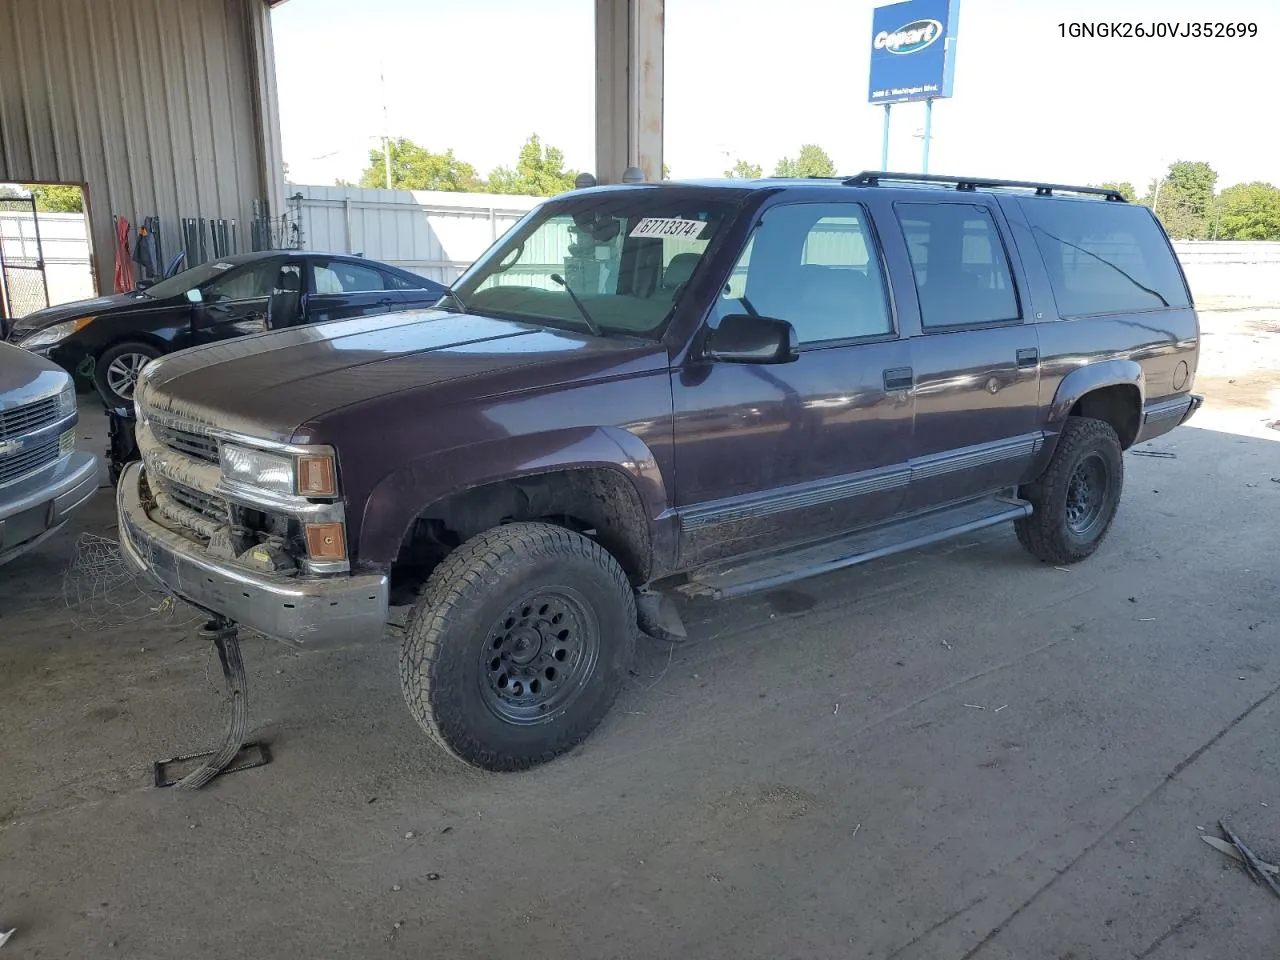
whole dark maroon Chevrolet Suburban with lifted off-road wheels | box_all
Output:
[118,173,1199,771]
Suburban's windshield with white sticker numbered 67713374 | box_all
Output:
[453,188,735,337]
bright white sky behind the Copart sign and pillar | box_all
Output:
[273,0,1280,192]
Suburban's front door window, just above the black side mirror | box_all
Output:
[716,204,893,344]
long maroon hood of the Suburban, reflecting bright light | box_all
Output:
[136,310,666,442]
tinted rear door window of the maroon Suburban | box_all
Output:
[893,204,1021,330]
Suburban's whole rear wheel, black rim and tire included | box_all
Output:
[1014,417,1124,566]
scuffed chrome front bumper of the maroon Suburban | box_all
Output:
[115,463,389,648]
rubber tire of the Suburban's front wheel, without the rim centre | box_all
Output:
[399,522,637,772]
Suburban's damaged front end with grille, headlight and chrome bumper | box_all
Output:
[116,392,389,646]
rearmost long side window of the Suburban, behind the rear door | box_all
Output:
[1019,200,1190,317]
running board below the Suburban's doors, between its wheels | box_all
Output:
[677,497,1032,600]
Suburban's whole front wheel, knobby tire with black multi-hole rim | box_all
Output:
[399,522,636,772]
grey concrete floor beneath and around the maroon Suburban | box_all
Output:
[0,311,1280,960]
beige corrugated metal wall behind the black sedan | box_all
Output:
[0,0,280,292]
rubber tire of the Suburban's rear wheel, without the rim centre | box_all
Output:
[1014,417,1124,566]
